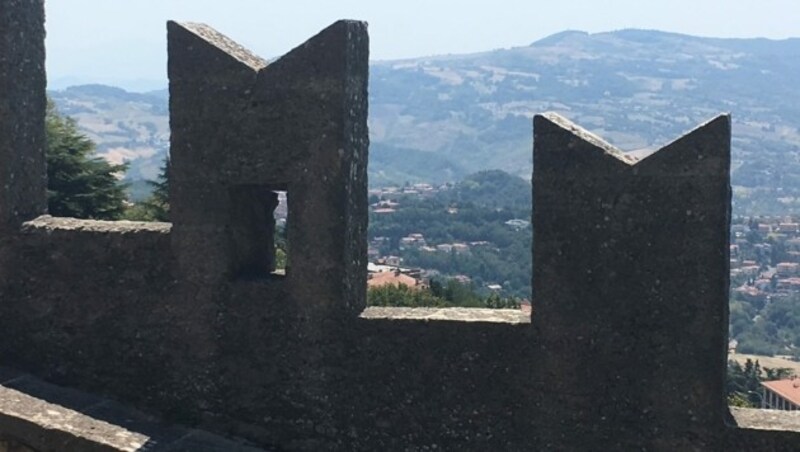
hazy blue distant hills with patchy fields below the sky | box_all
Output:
[52,30,800,213]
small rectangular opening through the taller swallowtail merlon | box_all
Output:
[230,185,289,279]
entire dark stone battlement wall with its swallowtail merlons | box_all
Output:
[0,6,800,451]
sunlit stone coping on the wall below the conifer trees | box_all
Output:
[22,215,172,234]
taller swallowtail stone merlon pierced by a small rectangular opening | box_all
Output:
[168,21,368,315]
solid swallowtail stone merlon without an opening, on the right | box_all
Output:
[533,114,730,448]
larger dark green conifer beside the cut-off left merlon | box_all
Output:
[45,102,127,220]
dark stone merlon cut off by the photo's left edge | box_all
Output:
[0,0,47,236]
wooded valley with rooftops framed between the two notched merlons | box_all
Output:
[367,177,532,317]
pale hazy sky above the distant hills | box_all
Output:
[46,0,800,90]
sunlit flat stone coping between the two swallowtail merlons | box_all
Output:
[360,306,531,325]
